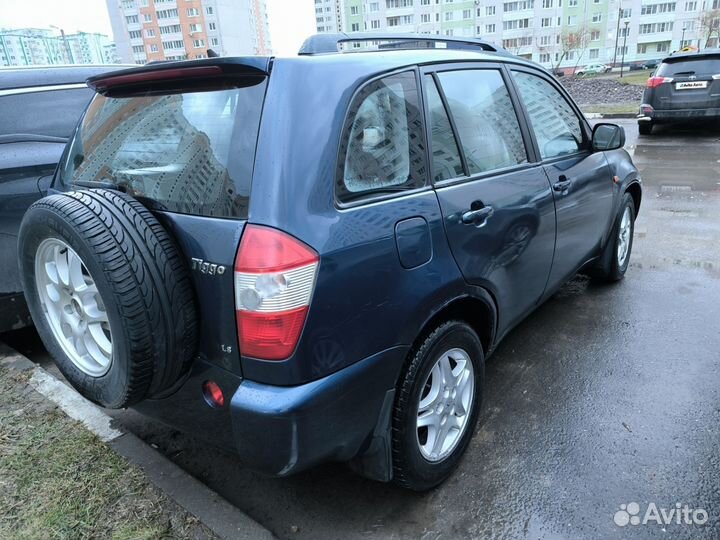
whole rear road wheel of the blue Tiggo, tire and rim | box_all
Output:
[392,321,484,491]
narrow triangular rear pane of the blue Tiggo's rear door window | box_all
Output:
[425,76,465,182]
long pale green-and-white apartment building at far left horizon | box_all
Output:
[0,28,118,66]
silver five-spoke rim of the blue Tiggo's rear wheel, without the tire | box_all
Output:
[416,349,475,461]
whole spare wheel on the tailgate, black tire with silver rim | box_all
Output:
[19,189,197,408]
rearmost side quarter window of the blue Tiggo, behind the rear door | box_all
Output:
[337,72,426,202]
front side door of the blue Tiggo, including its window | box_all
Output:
[512,68,615,288]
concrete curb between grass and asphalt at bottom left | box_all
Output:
[0,342,275,540]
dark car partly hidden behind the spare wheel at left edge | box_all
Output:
[0,65,128,332]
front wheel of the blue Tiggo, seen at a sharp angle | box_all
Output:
[589,193,635,282]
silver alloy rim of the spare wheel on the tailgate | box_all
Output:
[35,238,112,377]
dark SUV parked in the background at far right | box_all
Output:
[638,49,720,135]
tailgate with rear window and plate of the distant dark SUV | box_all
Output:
[653,54,720,110]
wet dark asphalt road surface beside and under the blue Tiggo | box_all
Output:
[2,121,720,540]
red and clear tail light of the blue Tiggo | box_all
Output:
[235,225,320,360]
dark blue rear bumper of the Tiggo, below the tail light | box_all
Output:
[136,347,408,479]
